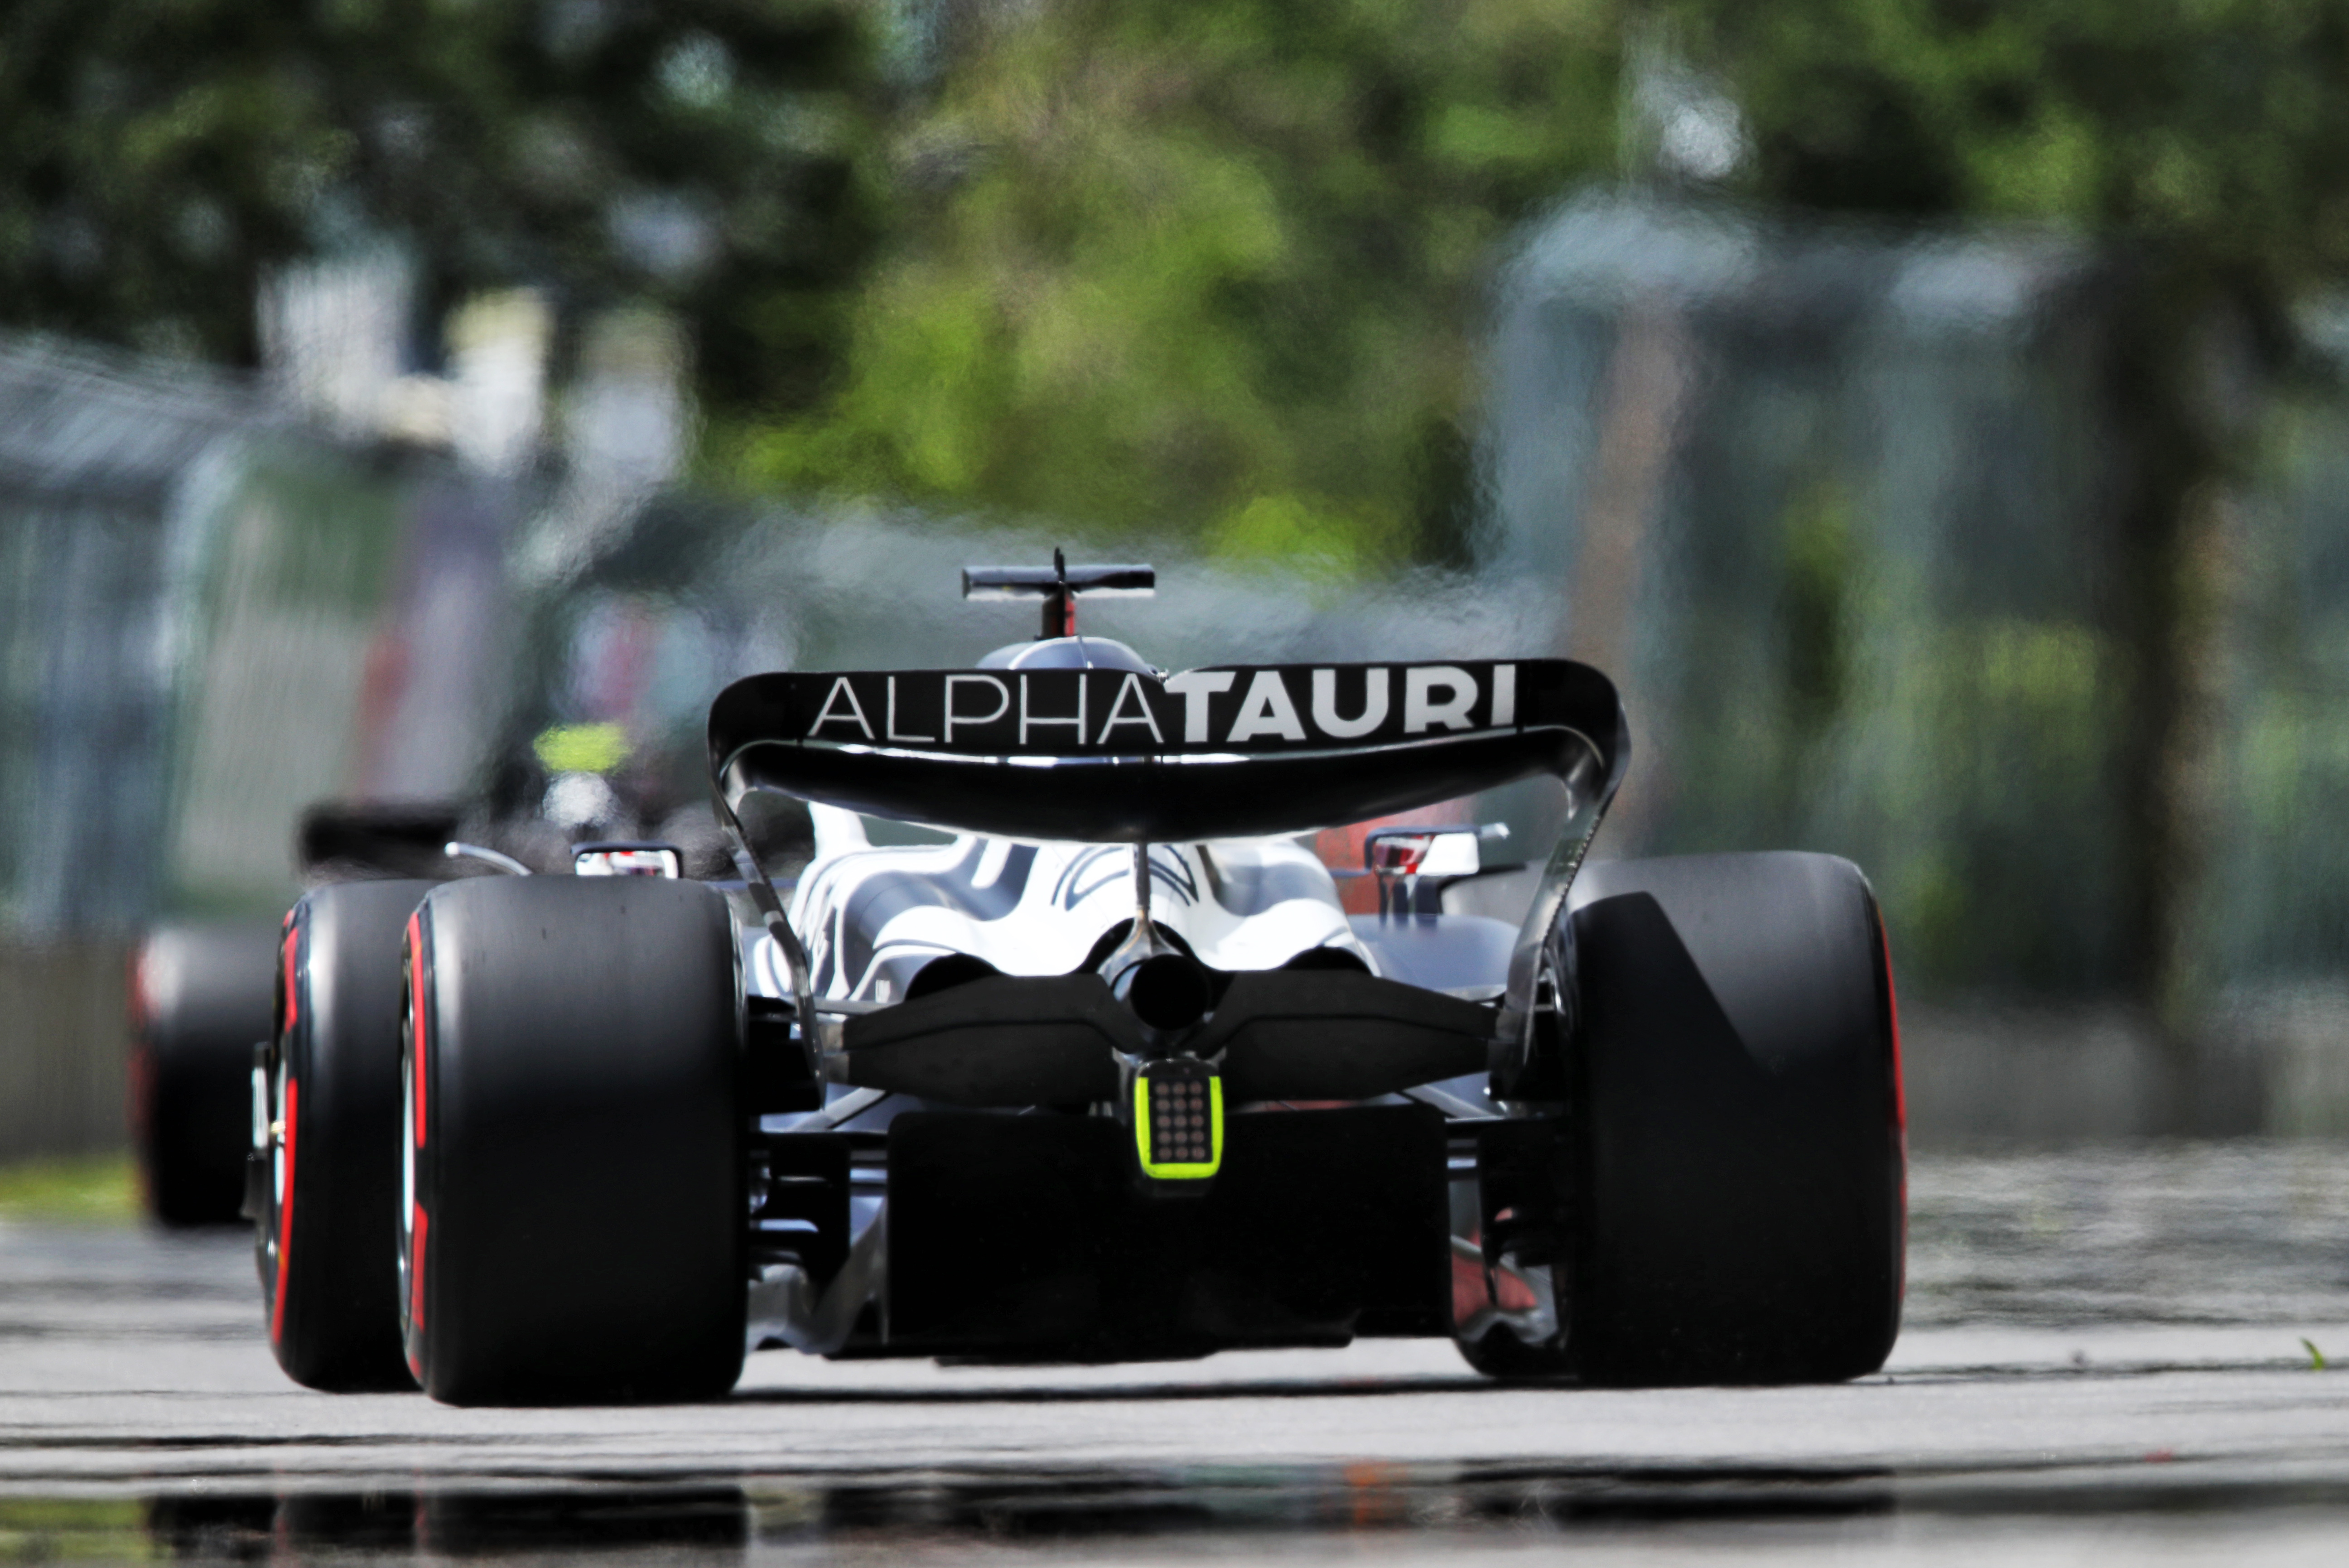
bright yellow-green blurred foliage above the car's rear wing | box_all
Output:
[740,0,1618,575]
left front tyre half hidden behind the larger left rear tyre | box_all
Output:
[254,880,432,1394]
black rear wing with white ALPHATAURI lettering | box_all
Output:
[709,660,1630,1047]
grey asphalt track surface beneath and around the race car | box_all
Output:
[14,1145,2349,1563]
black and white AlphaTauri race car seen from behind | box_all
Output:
[249,556,1905,1404]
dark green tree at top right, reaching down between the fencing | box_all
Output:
[1656,0,2349,1033]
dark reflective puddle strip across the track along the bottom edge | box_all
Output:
[14,1465,2349,1566]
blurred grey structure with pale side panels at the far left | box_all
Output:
[0,305,517,1153]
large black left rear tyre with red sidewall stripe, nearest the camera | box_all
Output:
[399,876,747,1404]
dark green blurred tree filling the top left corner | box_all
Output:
[0,0,878,409]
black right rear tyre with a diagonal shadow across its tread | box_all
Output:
[1562,854,1907,1385]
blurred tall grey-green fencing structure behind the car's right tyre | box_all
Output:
[1482,195,2349,1136]
